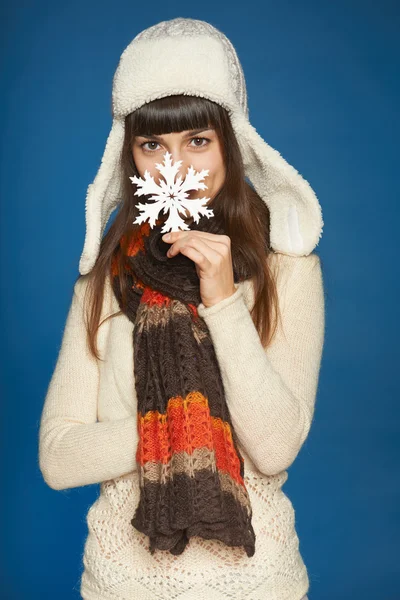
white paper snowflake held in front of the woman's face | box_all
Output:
[129,152,214,233]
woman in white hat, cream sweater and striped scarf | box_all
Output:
[39,18,324,600]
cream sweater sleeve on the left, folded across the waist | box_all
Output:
[39,278,137,490]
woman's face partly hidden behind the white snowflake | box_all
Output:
[132,128,225,221]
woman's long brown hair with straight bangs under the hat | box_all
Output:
[78,95,280,360]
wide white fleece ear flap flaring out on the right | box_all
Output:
[231,111,324,256]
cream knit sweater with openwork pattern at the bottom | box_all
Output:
[39,253,325,600]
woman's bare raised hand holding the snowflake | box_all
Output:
[162,230,236,308]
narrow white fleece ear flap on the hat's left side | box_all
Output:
[79,118,125,275]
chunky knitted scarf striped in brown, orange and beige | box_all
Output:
[112,217,255,557]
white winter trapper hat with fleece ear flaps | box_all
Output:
[79,17,323,275]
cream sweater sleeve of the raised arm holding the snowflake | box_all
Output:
[198,254,325,475]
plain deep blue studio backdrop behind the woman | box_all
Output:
[0,0,400,600]
